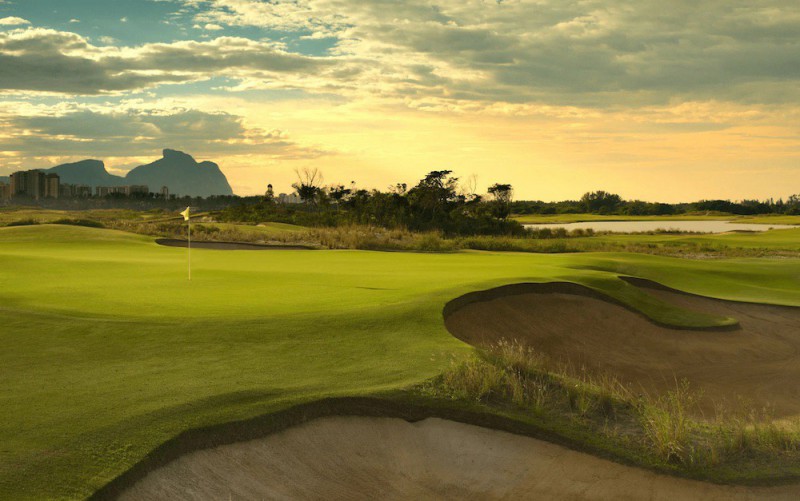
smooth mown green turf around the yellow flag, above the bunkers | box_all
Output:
[0,226,800,499]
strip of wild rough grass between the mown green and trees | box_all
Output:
[7,209,800,259]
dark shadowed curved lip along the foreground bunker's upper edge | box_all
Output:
[89,397,800,500]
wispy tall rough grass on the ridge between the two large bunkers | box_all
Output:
[417,341,800,481]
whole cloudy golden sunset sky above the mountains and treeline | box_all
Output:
[0,0,800,202]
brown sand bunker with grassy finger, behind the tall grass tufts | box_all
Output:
[445,281,800,417]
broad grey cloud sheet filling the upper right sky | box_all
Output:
[178,0,800,107]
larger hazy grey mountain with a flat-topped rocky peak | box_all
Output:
[125,149,233,197]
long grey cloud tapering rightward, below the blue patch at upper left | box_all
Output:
[0,28,336,95]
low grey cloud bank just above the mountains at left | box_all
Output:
[0,105,326,159]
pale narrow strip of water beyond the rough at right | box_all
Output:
[524,221,797,233]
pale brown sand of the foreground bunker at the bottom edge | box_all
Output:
[121,417,800,501]
